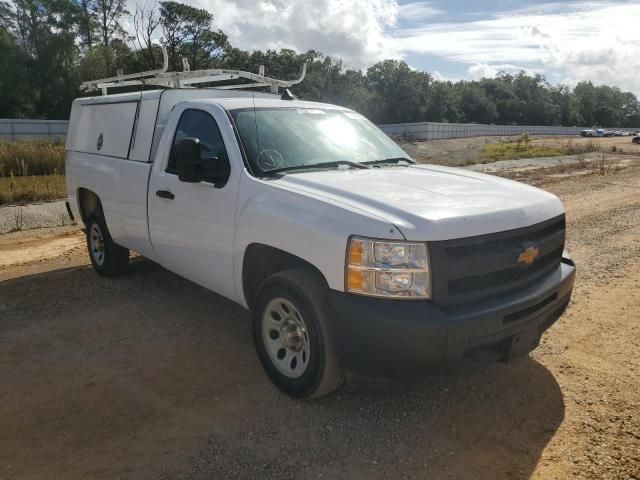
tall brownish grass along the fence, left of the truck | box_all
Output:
[0,139,65,177]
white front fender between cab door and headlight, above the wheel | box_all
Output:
[234,173,404,307]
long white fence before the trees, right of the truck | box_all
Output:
[380,122,635,140]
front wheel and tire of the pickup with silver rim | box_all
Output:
[252,269,344,399]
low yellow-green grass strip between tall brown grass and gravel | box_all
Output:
[0,174,67,205]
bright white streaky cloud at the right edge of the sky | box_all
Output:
[396,2,640,93]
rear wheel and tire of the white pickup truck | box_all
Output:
[87,210,129,277]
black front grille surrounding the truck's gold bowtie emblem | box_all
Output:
[429,215,565,305]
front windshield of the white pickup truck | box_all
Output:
[231,108,408,174]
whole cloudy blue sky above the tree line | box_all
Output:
[175,0,640,94]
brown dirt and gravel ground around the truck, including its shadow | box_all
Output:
[0,167,640,480]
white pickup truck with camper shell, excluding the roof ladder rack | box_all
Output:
[66,85,575,398]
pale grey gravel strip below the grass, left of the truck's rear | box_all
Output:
[0,200,72,234]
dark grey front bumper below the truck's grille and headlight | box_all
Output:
[329,258,575,377]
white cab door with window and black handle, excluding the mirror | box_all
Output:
[148,105,241,299]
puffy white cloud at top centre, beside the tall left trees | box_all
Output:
[190,0,400,67]
